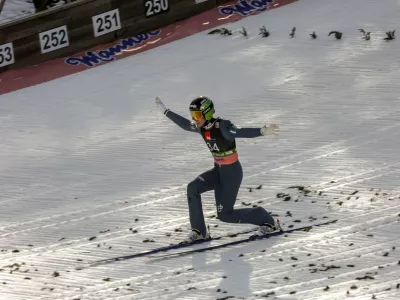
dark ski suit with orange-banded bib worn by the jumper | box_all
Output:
[164,109,275,236]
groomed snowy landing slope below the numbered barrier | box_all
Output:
[0,0,400,300]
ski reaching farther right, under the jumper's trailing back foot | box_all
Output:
[150,219,338,259]
